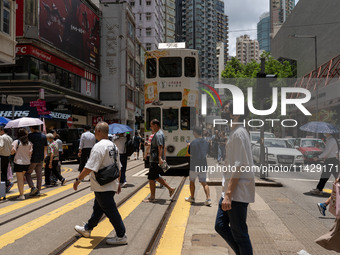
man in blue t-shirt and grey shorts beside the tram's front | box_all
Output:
[185,127,211,206]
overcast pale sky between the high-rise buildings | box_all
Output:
[224,0,298,56]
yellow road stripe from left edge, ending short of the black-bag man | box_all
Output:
[0,183,82,215]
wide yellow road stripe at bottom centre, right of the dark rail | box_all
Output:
[156,185,191,255]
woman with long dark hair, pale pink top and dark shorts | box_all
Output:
[11,128,33,200]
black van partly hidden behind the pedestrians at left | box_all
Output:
[56,128,84,161]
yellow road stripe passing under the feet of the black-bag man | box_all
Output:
[62,186,150,255]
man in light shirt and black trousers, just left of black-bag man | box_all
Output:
[78,125,96,172]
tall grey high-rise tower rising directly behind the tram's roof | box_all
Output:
[176,0,217,78]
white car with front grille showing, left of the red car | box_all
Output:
[252,138,304,165]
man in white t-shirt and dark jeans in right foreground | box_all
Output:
[215,102,255,255]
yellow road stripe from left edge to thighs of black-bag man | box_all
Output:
[0,193,94,249]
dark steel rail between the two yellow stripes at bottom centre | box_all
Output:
[143,177,186,255]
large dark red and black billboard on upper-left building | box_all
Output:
[39,0,99,68]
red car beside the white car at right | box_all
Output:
[295,138,325,164]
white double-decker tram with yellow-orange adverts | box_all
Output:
[144,43,199,175]
